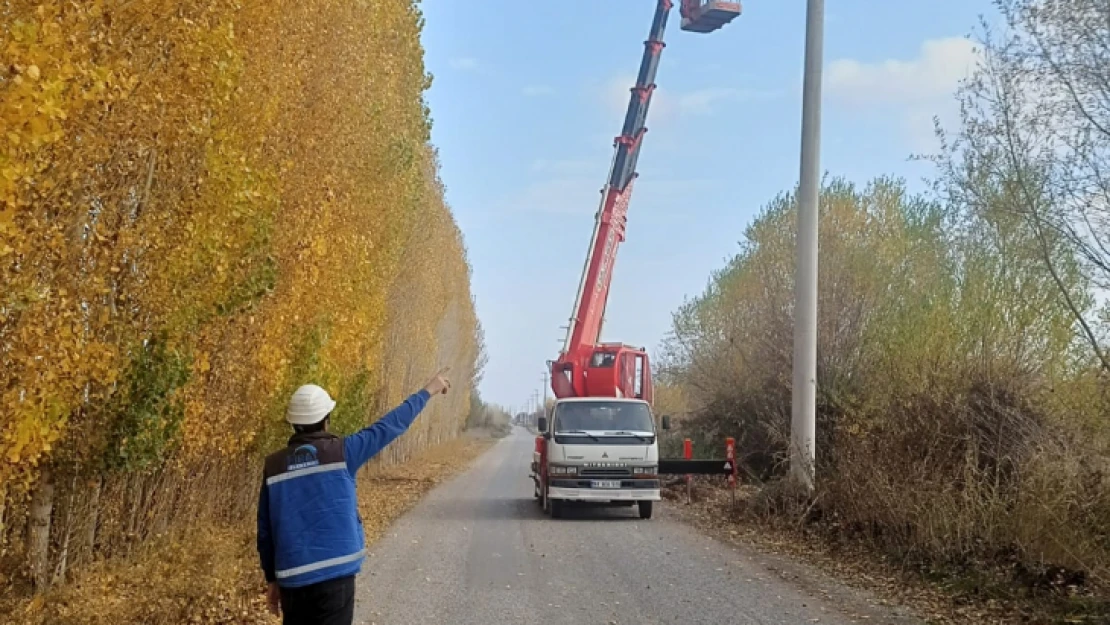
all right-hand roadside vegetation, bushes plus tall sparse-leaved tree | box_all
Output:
[658,0,1110,622]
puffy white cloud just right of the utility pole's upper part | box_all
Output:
[826,37,979,104]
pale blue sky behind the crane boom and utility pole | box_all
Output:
[421,0,992,409]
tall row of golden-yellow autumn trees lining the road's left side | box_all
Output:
[0,0,481,599]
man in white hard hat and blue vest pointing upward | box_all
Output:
[258,369,451,625]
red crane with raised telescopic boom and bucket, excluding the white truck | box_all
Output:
[551,0,740,402]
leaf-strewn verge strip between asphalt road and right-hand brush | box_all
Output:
[664,477,1110,625]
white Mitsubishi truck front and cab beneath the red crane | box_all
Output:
[532,397,668,518]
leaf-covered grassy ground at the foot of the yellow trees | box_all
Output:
[0,437,494,625]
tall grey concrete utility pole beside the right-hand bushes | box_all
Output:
[790,0,825,490]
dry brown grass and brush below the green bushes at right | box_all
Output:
[657,374,1110,623]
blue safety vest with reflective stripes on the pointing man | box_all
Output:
[262,432,366,587]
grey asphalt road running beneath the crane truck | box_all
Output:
[355,429,912,625]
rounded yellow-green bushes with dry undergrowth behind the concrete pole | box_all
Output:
[657,173,1110,608]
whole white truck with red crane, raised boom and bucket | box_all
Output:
[531,0,740,518]
